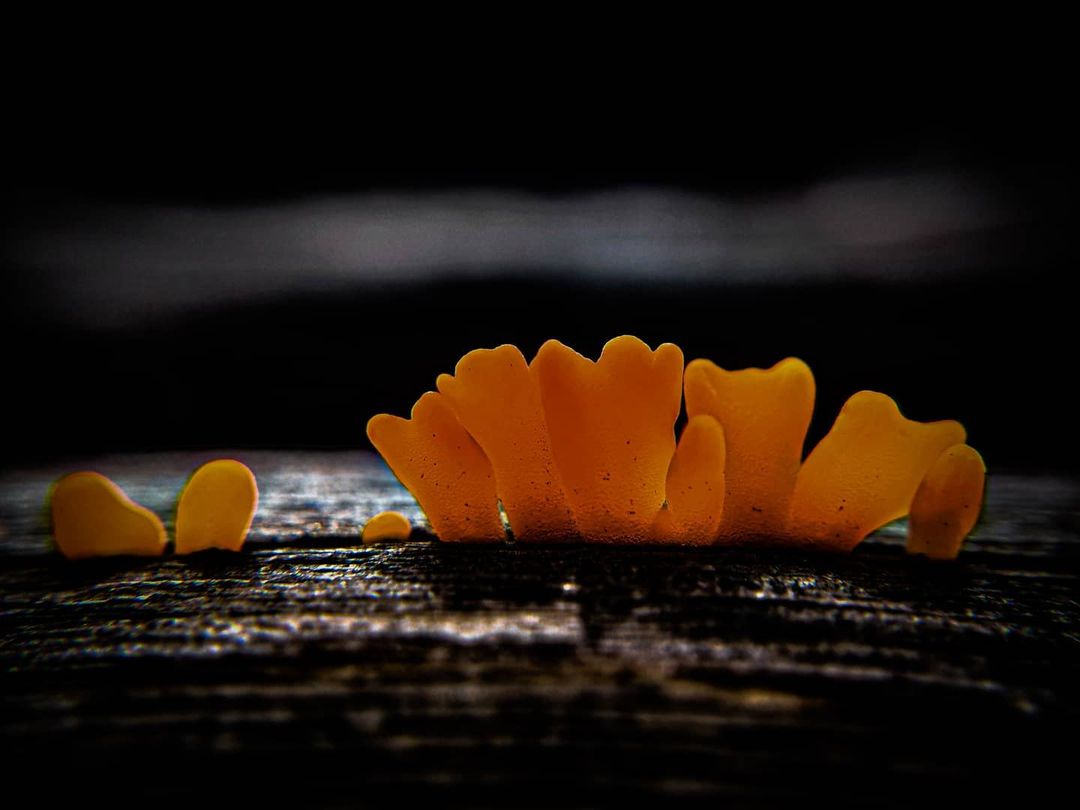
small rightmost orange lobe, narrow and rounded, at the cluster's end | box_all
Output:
[907,444,986,559]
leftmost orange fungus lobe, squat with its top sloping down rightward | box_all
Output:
[50,472,167,559]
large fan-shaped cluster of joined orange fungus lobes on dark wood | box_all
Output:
[365,336,984,556]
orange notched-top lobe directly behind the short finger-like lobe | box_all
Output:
[686,357,814,541]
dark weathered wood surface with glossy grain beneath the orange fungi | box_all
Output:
[0,454,1080,807]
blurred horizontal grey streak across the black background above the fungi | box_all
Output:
[5,174,1023,326]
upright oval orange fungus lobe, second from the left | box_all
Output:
[176,459,259,554]
